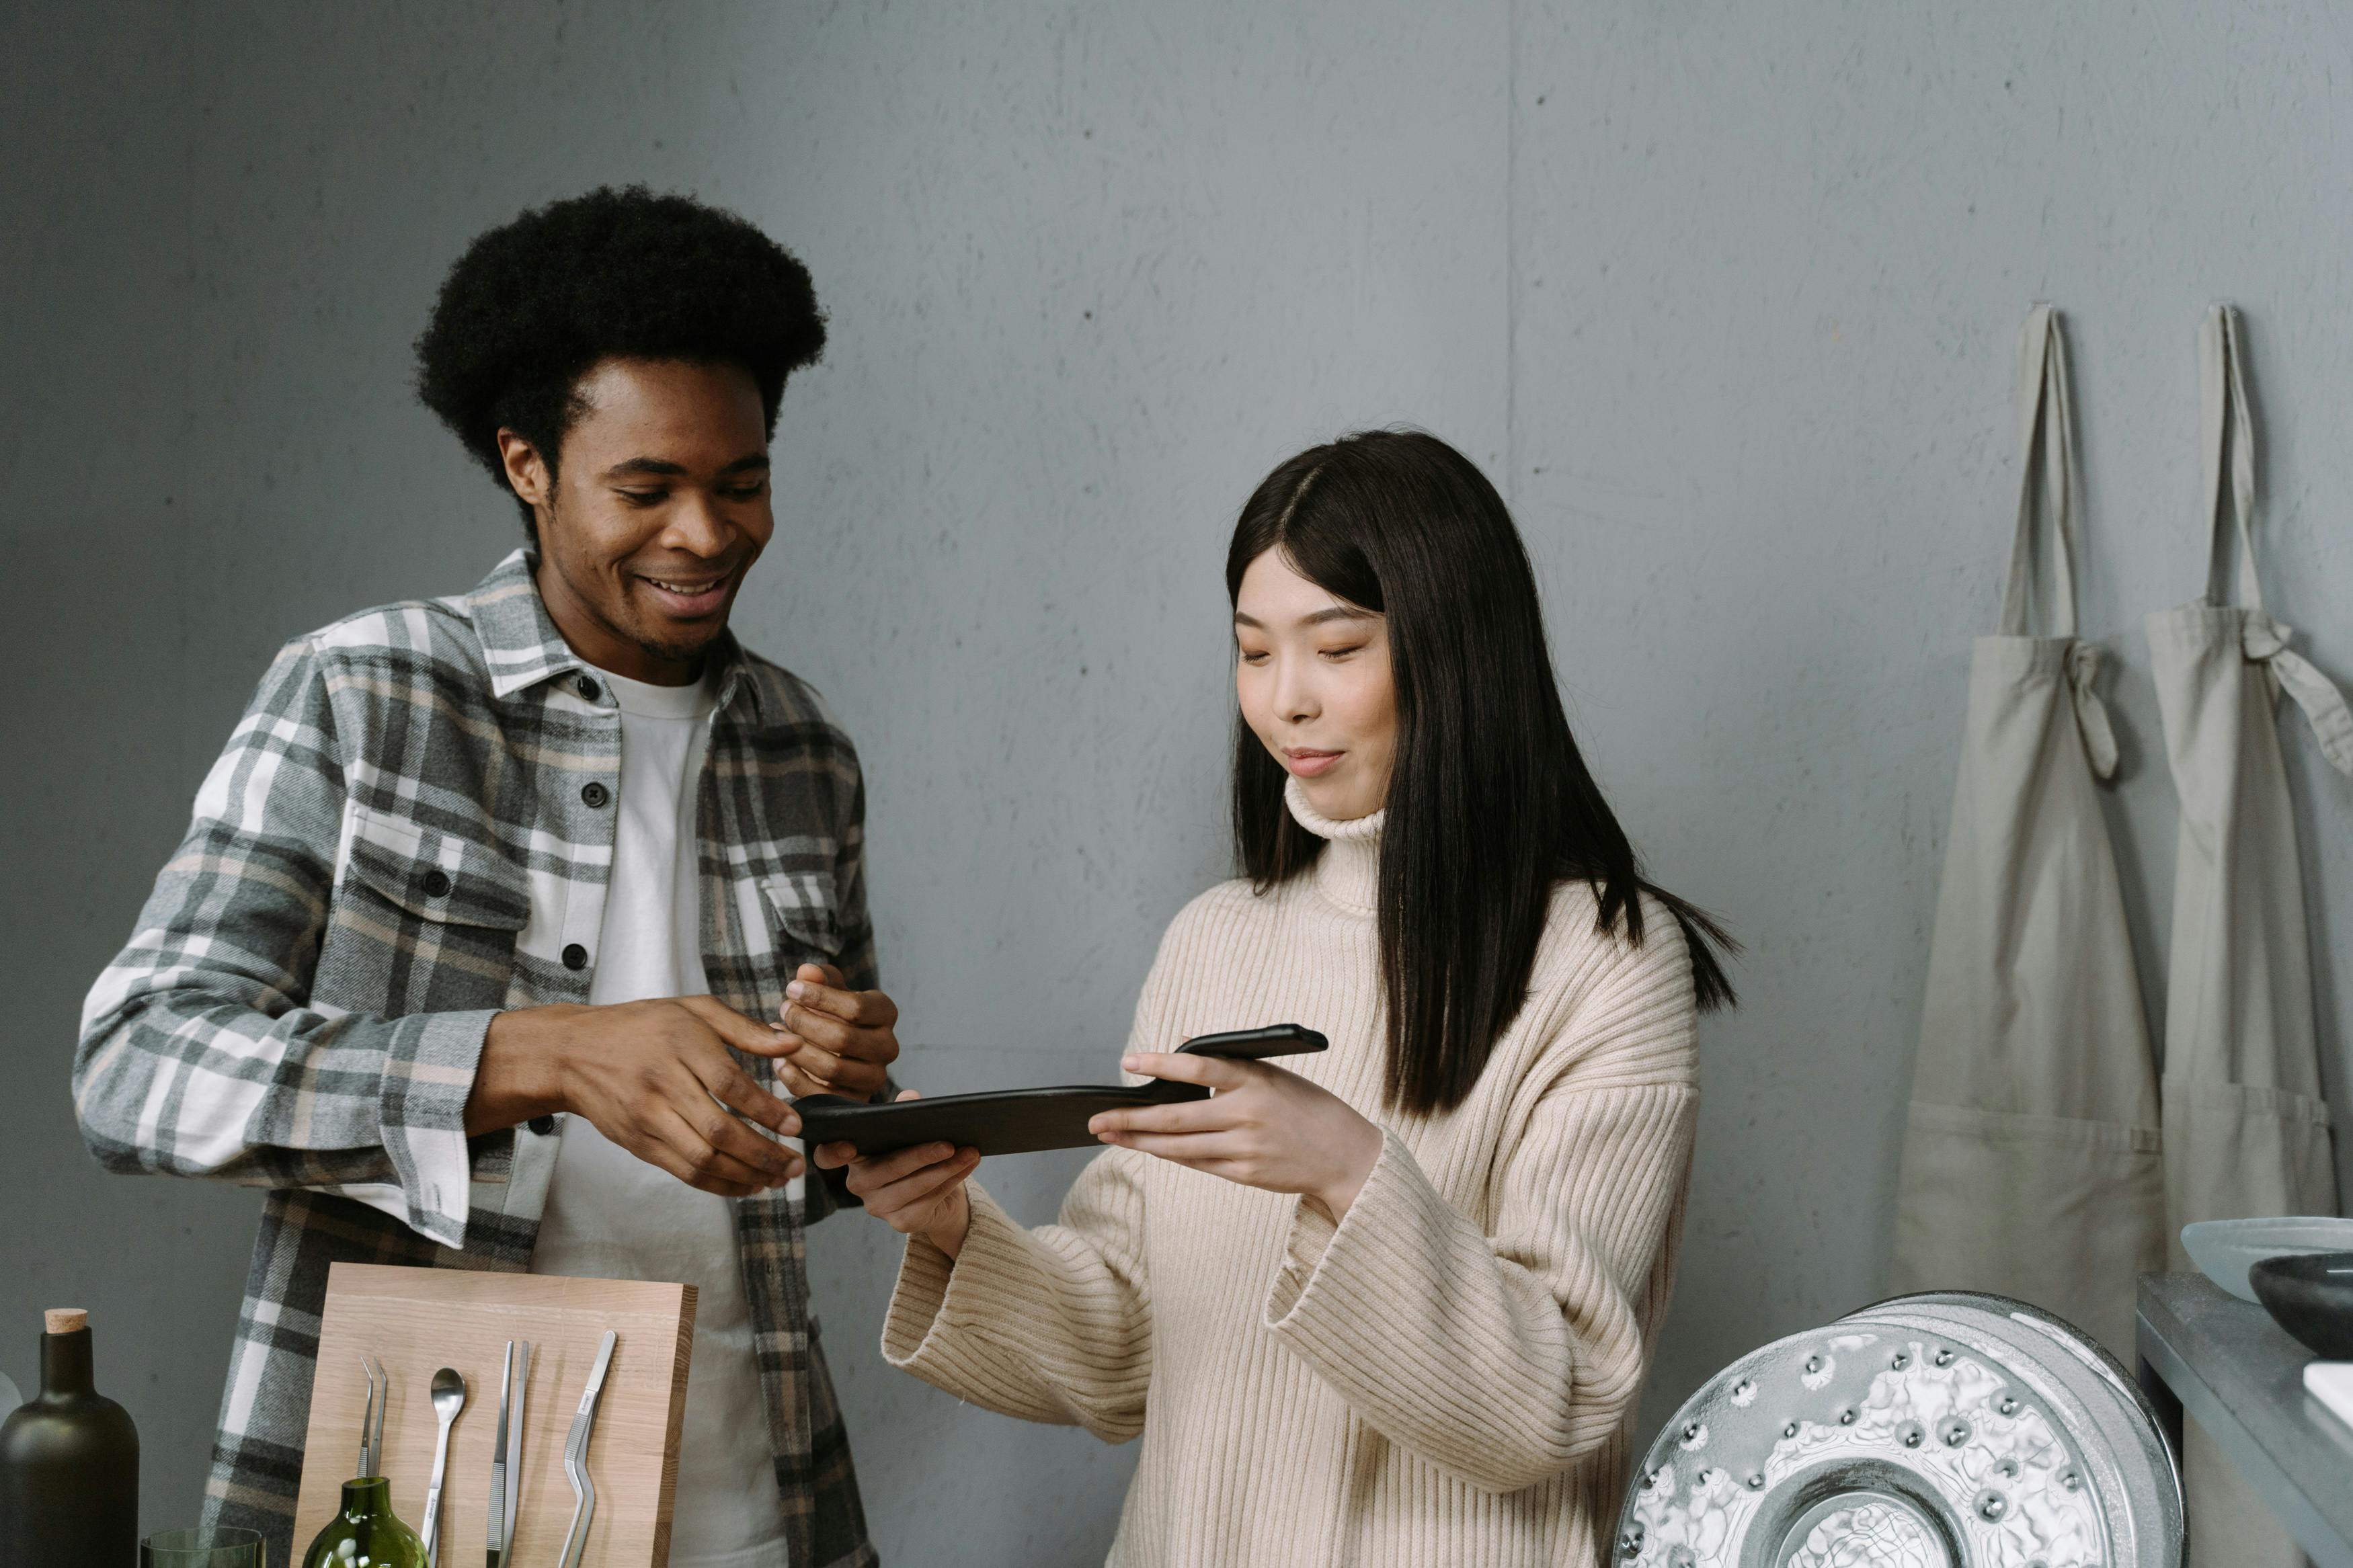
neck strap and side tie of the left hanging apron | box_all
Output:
[2003,306,2116,780]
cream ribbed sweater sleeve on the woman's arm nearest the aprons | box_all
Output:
[1266,938,1699,1493]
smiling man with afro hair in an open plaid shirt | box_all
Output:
[73,188,899,1568]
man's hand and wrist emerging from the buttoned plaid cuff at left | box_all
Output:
[466,997,803,1199]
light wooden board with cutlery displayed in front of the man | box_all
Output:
[294,1262,694,1568]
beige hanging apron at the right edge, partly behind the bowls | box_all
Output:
[2149,306,2353,1568]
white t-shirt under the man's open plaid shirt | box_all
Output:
[532,670,786,1568]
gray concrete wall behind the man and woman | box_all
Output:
[0,0,2353,1563]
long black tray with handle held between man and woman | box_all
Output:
[793,1023,1327,1159]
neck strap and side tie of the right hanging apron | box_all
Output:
[2198,306,2353,776]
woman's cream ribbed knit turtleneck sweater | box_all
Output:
[883,783,1699,1568]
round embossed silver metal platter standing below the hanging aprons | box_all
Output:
[1614,1290,2184,1568]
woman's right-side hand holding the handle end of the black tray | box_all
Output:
[1087,1050,1382,1223]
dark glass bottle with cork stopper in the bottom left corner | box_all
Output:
[0,1307,139,1568]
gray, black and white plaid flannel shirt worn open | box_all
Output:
[73,550,875,1568]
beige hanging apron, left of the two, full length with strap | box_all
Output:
[1892,306,2165,1366]
